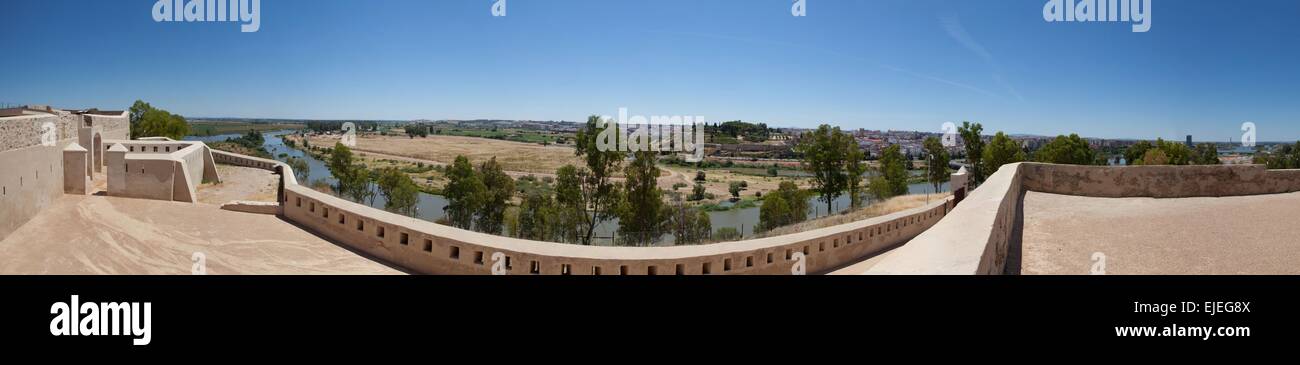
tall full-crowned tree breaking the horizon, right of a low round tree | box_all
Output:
[796,125,857,212]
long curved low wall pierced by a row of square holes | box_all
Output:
[213,151,953,275]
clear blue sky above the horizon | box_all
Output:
[0,0,1300,142]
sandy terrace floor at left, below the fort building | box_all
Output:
[0,195,400,274]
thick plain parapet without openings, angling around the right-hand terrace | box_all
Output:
[858,164,1300,275]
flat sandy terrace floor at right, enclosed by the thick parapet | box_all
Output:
[1021,192,1300,274]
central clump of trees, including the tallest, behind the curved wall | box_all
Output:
[443,116,712,245]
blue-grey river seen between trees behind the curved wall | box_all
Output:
[185,130,948,245]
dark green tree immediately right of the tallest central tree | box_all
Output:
[619,151,667,245]
